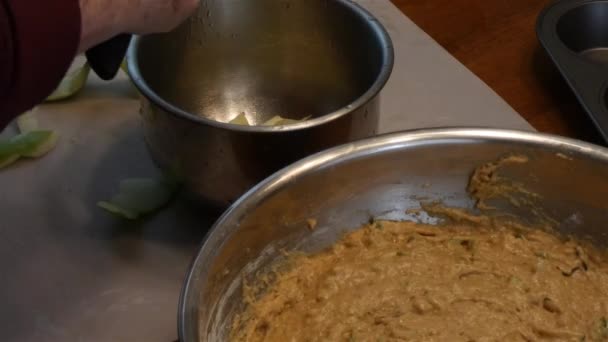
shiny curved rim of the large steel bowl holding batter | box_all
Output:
[178,127,608,342]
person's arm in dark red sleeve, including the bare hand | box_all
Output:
[0,0,198,130]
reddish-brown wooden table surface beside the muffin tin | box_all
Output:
[392,0,599,142]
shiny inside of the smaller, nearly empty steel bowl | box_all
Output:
[137,0,389,124]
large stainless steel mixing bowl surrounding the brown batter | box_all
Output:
[179,129,608,342]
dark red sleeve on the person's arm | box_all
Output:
[0,0,80,130]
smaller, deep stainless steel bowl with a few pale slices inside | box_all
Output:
[128,0,393,207]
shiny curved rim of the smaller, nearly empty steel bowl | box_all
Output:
[126,0,395,133]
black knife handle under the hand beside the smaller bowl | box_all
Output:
[86,34,131,81]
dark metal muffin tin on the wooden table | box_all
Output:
[536,0,608,142]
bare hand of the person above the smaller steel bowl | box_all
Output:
[78,0,199,51]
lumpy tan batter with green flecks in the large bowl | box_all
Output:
[231,220,608,341]
